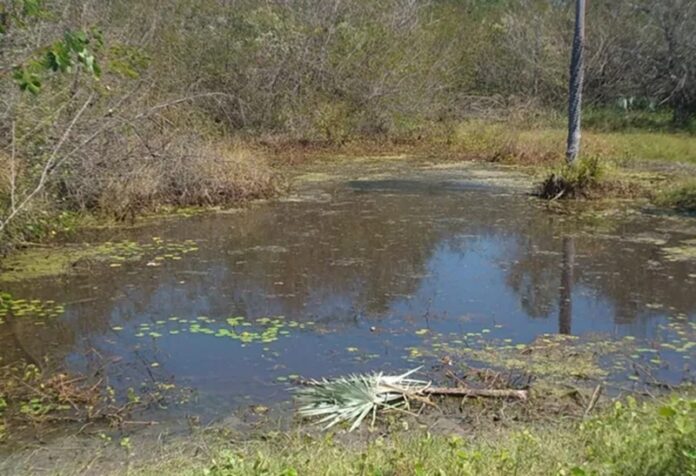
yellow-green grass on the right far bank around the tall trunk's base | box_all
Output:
[440,117,696,206]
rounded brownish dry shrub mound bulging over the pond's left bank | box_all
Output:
[54,125,279,220]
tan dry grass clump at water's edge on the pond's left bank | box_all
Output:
[68,141,280,219]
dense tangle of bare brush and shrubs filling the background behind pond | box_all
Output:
[0,0,696,242]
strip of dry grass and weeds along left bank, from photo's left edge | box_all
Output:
[0,140,284,247]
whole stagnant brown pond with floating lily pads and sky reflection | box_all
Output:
[0,161,696,432]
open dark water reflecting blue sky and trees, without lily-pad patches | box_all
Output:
[0,169,696,410]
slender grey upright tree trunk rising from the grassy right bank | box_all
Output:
[566,0,585,165]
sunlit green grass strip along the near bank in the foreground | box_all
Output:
[133,396,696,476]
